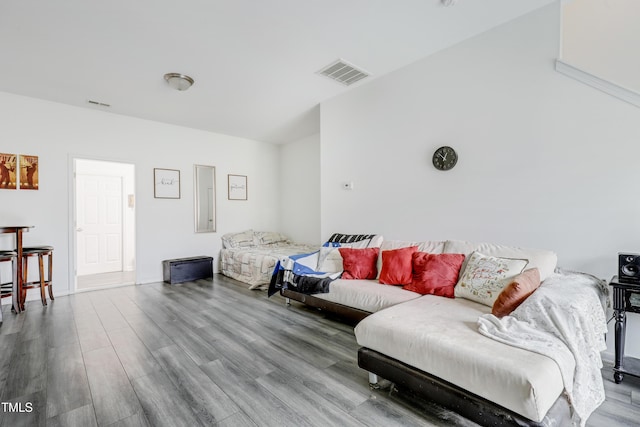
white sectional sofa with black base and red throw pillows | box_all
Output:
[280,240,606,426]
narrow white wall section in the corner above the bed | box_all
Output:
[280,134,320,245]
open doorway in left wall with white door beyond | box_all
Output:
[74,159,135,291]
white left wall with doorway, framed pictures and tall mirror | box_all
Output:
[0,93,279,295]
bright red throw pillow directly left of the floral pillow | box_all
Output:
[404,252,464,298]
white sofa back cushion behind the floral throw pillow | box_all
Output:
[444,240,558,281]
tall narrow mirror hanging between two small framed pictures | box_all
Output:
[194,165,216,233]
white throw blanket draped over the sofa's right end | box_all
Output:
[478,272,608,426]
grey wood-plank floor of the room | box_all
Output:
[0,275,640,427]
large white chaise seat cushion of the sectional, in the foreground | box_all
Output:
[355,295,564,422]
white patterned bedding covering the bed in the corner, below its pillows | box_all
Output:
[220,242,318,289]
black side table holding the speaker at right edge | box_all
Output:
[609,276,640,384]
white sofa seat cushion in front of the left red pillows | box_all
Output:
[314,279,421,313]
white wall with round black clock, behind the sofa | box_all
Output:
[321,5,640,355]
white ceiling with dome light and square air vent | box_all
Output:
[0,0,555,143]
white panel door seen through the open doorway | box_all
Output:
[76,175,122,276]
